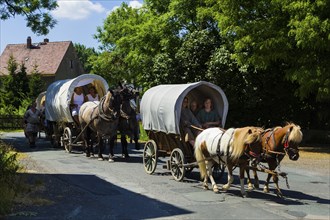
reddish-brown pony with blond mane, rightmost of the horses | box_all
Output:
[246,123,303,197]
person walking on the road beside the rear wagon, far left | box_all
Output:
[24,102,41,148]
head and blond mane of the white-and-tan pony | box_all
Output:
[232,127,263,162]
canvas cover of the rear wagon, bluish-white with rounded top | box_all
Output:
[45,74,109,122]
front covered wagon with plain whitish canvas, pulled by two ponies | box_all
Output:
[140,81,228,181]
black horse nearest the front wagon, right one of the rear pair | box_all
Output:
[110,89,140,159]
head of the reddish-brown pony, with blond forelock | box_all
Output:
[282,123,303,161]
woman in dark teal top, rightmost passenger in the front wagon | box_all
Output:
[197,98,221,128]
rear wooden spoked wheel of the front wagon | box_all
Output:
[143,140,158,174]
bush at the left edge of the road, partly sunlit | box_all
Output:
[0,140,20,216]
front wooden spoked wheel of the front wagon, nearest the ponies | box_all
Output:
[170,148,186,181]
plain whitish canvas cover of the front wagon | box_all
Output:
[140,81,228,134]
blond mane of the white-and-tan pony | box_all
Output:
[231,127,262,160]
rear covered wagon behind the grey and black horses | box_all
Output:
[45,74,109,151]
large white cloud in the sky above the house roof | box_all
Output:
[52,0,105,20]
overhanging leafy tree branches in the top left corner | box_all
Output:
[0,0,58,35]
